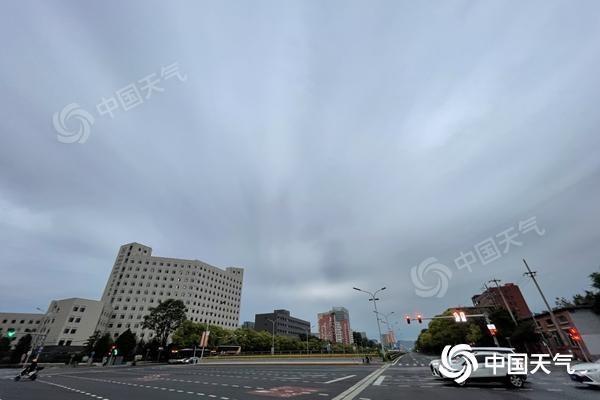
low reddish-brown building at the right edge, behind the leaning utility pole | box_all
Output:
[530,306,600,360]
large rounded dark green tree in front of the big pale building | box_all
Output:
[142,299,187,347]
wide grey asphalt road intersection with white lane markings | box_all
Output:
[0,353,600,400]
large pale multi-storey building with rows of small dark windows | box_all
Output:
[102,243,244,341]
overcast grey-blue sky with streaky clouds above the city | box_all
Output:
[0,0,600,338]
